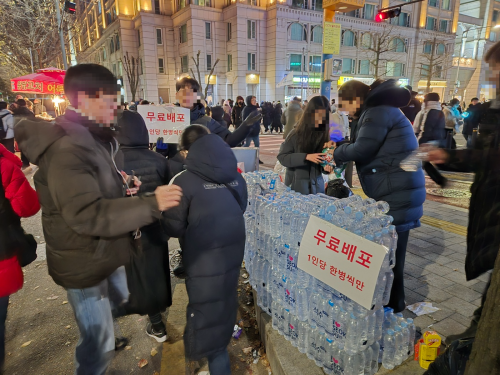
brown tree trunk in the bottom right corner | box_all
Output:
[465,256,500,375]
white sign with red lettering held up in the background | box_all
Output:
[137,105,190,143]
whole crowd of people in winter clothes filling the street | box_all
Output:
[0,39,500,375]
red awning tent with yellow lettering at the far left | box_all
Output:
[10,68,66,95]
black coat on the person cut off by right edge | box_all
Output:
[440,104,500,280]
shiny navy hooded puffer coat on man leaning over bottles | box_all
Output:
[334,80,426,232]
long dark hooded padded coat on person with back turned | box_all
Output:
[163,134,247,360]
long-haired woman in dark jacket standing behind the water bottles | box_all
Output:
[278,96,333,194]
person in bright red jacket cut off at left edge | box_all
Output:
[0,144,40,374]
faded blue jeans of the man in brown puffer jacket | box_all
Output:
[66,268,127,375]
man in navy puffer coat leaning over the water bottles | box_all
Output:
[334,80,426,312]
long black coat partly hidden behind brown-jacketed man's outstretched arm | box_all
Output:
[118,111,172,315]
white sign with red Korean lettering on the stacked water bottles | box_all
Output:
[297,216,387,309]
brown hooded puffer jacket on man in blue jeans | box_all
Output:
[14,108,160,289]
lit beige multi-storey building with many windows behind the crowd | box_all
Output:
[76,0,462,104]
